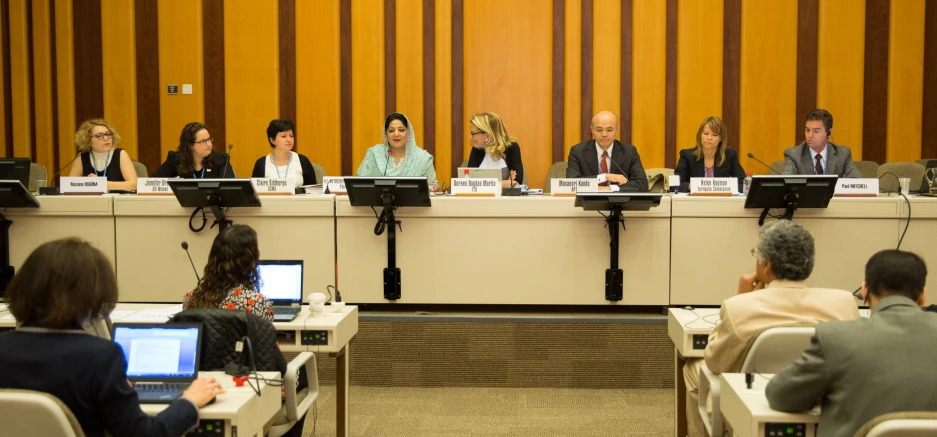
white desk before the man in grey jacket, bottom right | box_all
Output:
[719,373,820,437]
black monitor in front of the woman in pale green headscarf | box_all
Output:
[345,176,432,207]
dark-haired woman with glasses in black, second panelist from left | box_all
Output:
[153,121,234,179]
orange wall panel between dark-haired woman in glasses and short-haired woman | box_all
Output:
[226,0,280,176]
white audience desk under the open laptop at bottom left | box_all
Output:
[140,372,280,437]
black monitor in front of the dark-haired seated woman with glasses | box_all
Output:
[169,179,261,208]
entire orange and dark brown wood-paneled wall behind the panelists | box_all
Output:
[0,0,937,187]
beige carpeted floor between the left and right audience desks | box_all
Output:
[304,386,674,437]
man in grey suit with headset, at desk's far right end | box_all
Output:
[784,109,862,178]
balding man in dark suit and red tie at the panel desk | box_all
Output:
[566,111,647,192]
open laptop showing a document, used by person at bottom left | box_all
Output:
[111,323,202,404]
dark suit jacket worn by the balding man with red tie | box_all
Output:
[566,140,647,192]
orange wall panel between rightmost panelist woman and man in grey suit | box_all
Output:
[739,0,797,174]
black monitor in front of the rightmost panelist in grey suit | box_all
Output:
[745,175,839,209]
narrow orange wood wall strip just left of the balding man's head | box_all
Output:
[564,0,585,158]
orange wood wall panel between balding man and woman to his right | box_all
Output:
[622,1,667,168]
